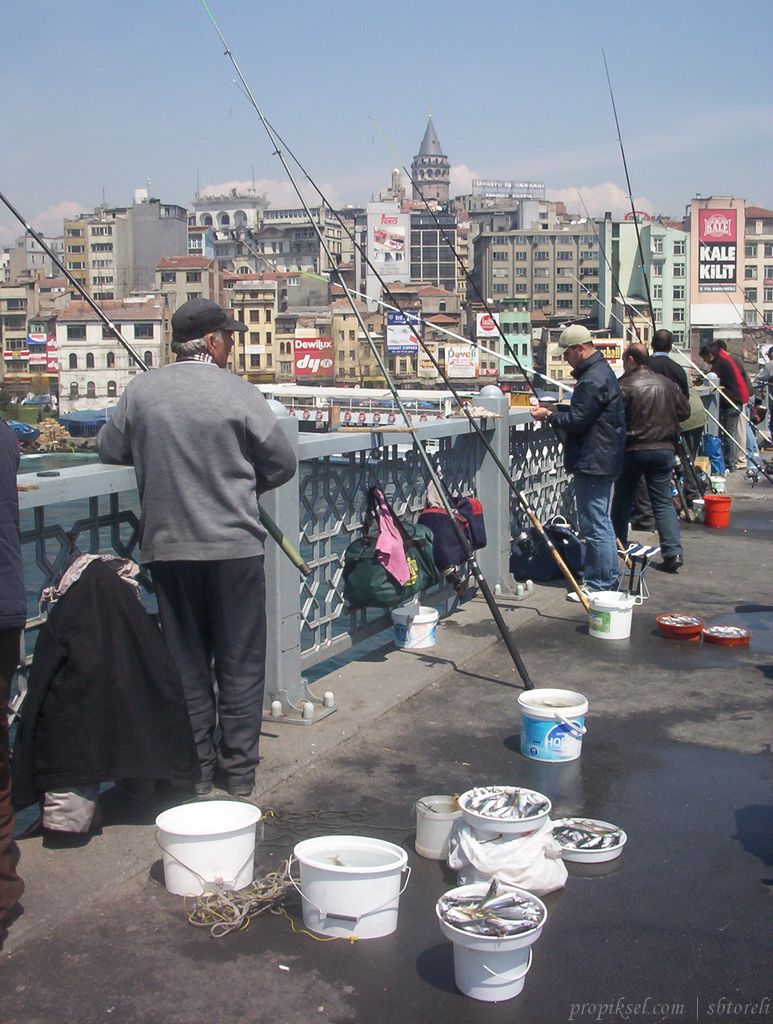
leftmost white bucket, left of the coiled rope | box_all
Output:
[156,800,260,896]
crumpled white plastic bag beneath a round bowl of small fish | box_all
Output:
[448,818,567,896]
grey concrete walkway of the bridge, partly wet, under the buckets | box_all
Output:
[0,474,773,1024]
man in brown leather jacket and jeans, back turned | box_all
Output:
[612,344,690,572]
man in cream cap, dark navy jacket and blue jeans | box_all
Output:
[531,324,626,601]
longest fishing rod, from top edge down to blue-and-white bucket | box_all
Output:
[201,0,533,689]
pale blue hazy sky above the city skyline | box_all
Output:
[0,0,773,245]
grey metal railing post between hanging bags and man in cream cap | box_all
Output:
[475,385,513,593]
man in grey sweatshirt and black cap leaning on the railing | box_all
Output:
[97,299,296,797]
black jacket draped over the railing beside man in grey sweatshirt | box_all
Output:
[12,561,200,808]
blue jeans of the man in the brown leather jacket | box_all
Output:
[612,449,683,558]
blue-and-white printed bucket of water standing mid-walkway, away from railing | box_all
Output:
[518,689,588,762]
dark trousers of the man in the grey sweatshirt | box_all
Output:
[151,555,266,782]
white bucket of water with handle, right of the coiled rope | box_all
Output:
[291,836,411,939]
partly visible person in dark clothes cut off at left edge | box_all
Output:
[0,420,27,946]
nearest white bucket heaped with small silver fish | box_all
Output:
[435,880,548,1002]
